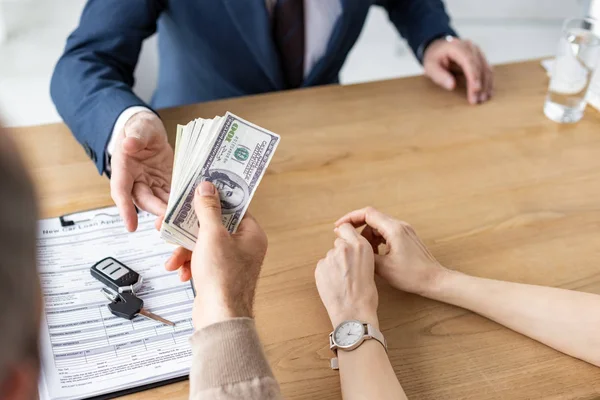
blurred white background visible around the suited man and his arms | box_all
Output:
[0,0,589,126]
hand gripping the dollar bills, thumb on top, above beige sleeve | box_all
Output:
[186,182,267,329]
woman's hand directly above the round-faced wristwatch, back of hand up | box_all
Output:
[315,224,379,327]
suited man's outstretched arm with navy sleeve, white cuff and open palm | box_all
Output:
[51,0,173,231]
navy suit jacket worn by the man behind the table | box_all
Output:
[50,0,455,173]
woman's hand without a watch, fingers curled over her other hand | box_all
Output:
[336,207,448,295]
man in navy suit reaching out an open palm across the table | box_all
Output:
[51,0,493,230]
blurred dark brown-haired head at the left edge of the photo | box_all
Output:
[0,127,41,400]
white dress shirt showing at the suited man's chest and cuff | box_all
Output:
[106,0,342,159]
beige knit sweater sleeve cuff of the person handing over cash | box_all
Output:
[190,318,282,400]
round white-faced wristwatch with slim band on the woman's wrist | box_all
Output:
[329,319,387,370]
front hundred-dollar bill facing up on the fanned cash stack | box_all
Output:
[164,113,280,249]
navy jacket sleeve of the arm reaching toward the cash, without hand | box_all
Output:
[50,0,166,173]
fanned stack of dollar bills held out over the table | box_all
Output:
[160,112,279,250]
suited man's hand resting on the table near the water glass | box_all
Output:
[423,38,494,104]
